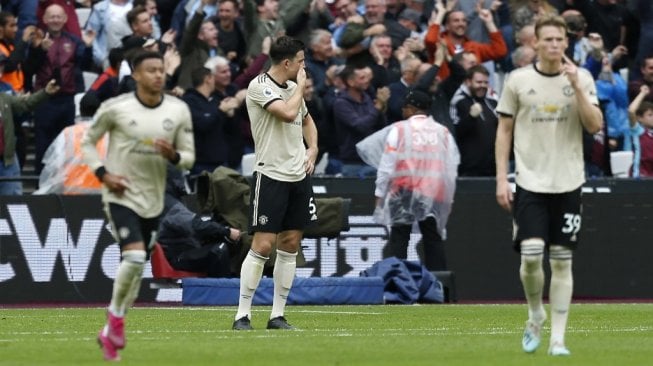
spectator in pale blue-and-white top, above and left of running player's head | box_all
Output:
[86,0,132,68]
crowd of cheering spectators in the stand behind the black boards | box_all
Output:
[0,0,653,194]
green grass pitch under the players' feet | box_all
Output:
[0,304,653,366]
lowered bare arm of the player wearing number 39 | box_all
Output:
[494,115,515,211]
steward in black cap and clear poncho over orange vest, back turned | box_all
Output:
[374,90,460,271]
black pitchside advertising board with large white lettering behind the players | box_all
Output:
[0,178,653,304]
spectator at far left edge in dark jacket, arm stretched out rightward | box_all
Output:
[0,55,59,196]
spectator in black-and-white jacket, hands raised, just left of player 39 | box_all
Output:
[450,65,499,177]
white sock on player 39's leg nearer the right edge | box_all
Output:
[549,245,574,345]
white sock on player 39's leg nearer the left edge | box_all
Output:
[519,239,546,323]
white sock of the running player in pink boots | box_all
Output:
[109,250,146,317]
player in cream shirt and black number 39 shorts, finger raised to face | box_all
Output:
[495,16,603,356]
